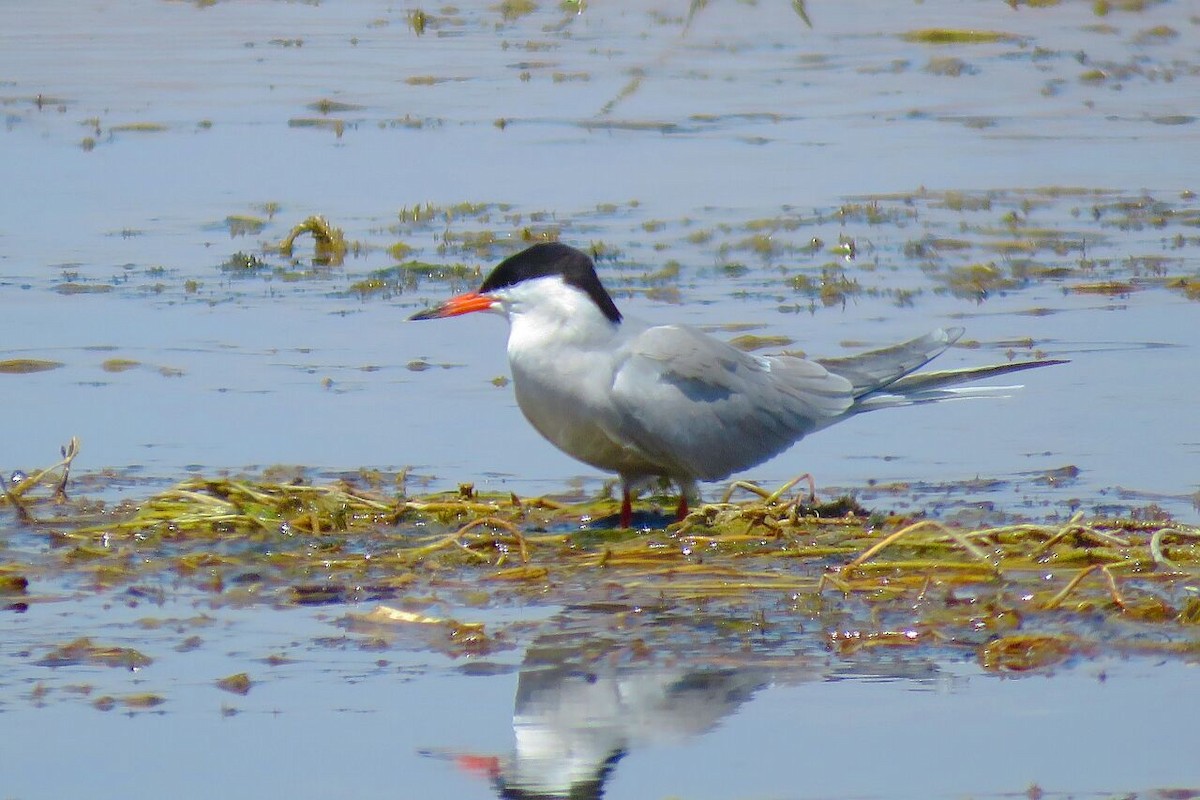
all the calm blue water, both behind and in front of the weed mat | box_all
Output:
[0,0,1200,798]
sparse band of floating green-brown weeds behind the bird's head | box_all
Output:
[35,186,1180,314]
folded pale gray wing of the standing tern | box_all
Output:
[612,325,854,481]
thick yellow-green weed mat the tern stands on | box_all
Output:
[0,441,1200,671]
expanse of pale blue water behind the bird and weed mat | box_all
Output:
[0,2,1200,513]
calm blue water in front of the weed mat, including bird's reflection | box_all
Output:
[0,587,1196,798]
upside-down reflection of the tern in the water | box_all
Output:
[426,602,953,800]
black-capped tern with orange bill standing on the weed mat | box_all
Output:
[410,241,1063,528]
